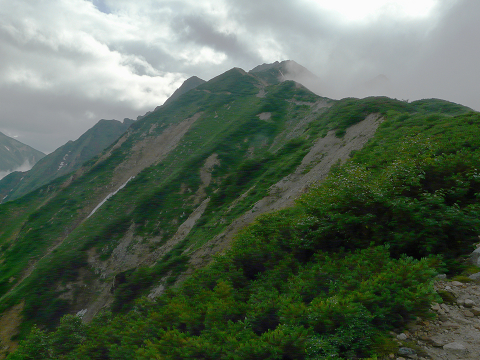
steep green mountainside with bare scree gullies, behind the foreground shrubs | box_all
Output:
[0,62,472,354]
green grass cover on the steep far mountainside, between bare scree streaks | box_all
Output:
[0,69,336,334]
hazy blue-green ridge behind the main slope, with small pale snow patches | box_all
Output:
[0,119,134,202]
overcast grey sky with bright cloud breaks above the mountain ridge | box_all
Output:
[0,0,480,152]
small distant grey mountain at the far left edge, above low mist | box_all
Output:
[0,133,45,179]
